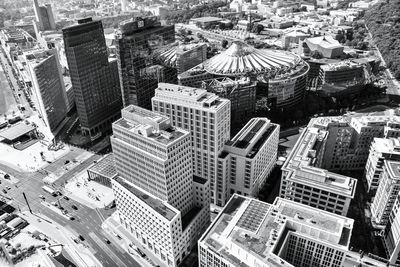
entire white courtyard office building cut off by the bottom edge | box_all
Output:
[198,194,386,267]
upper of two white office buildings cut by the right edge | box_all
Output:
[365,138,400,193]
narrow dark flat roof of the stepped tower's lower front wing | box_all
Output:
[114,176,178,221]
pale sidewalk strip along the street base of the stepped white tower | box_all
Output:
[101,212,156,267]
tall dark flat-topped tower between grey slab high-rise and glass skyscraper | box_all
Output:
[63,18,121,139]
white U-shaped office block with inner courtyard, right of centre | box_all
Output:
[280,117,357,216]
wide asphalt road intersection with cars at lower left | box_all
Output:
[0,155,140,267]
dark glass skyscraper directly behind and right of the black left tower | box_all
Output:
[116,17,177,109]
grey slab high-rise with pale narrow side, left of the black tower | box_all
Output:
[25,49,67,134]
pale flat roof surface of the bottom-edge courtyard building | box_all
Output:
[200,194,353,266]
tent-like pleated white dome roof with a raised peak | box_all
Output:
[203,41,303,77]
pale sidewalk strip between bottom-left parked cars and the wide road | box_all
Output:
[19,211,103,267]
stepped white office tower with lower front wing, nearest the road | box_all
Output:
[111,105,210,266]
